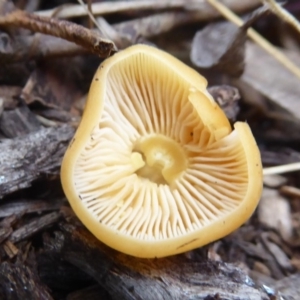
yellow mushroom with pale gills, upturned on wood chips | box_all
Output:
[61,45,262,258]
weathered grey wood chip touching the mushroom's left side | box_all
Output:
[0,125,74,198]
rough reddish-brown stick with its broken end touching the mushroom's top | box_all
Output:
[0,10,117,57]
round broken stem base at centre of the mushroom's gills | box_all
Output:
[132,134,187,184]
